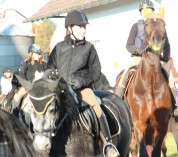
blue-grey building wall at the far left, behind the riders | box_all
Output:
[0,36,34,76]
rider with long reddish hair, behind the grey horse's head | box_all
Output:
[12,44,47,112]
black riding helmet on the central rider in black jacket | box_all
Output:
[65,10,88,28]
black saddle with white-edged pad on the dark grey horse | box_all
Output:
[79,90,120,137]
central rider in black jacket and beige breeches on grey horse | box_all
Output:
[45,10,118,154]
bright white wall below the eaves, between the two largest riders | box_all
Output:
[86,10,140,86]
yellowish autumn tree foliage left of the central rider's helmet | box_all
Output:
[34,19,56,52]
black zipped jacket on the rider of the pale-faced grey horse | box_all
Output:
[47,37,101,88]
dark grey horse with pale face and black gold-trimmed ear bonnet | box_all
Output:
[18,74,132,157]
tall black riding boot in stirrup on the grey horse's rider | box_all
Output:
[98,113,119,157]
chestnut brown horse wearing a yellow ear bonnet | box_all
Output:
[114,7,171,157]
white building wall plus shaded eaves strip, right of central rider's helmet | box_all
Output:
[85,0,140,86]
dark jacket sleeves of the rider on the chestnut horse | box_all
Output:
[126,20,170,62]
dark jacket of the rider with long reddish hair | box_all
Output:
[18,60,47,81]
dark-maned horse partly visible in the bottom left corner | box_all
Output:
[0,109,42,157]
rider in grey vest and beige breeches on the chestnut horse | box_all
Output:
[116,0,170,97]
